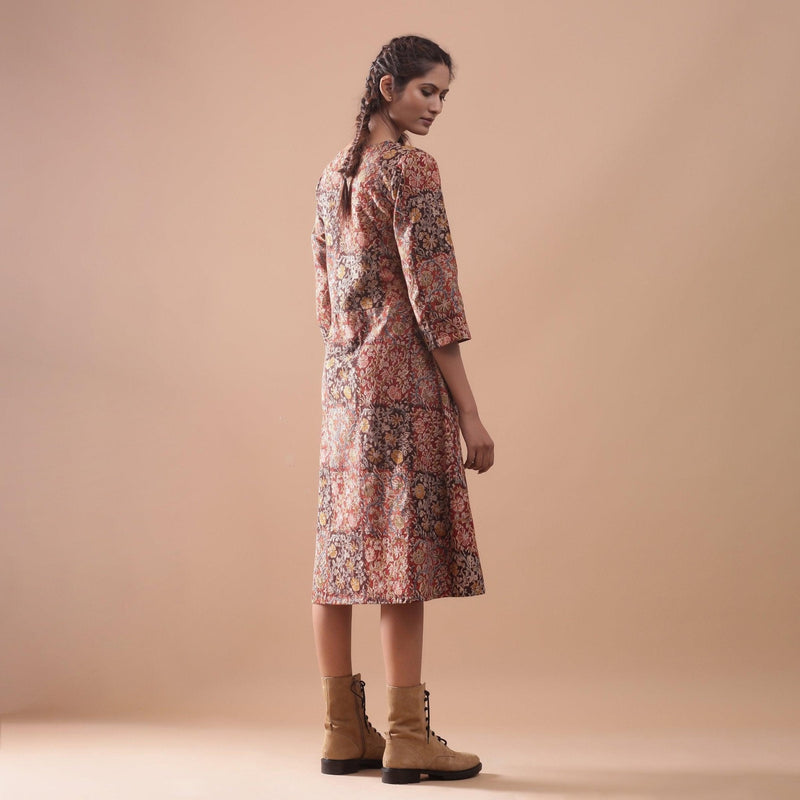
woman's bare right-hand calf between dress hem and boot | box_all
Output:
[381,601,425,686]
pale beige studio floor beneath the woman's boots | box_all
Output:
[0,716,800,800]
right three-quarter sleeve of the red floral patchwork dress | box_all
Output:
[393,149,471,350]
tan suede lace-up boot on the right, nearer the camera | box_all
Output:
[382,683,482,783]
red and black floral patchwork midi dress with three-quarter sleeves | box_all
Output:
[311,141,485,604]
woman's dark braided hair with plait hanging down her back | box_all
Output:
[339,36,453,216]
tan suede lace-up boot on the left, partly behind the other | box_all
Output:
[322,674,386,775]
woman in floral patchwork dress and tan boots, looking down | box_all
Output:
[312,36,494,783]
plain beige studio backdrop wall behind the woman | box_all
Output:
[0,0,800,725]
